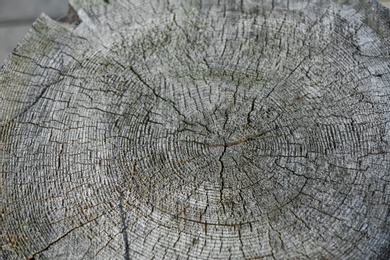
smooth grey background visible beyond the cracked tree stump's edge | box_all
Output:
[0,0,390,66]
